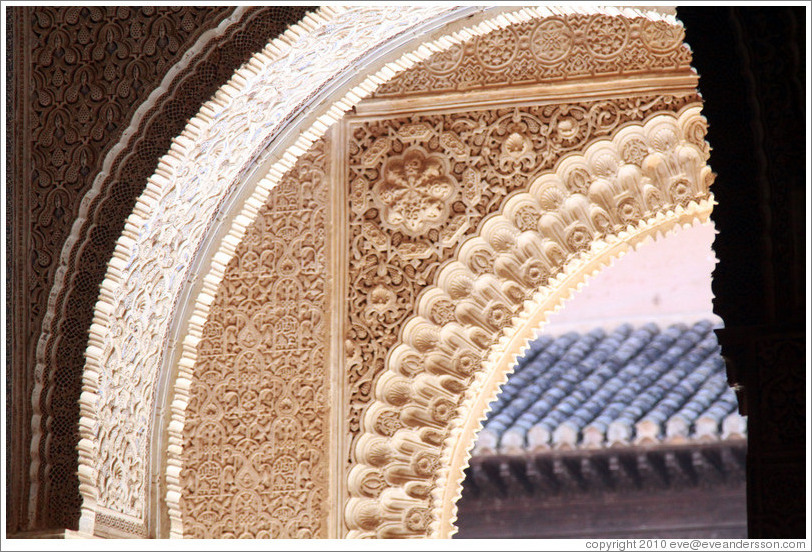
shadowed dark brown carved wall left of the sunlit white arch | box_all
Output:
[7,6,314,533]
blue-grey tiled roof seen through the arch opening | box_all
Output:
[474,321,746,455]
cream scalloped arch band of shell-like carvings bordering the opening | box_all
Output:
[346,106,713,537]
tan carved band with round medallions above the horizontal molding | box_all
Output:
[374,13,691,98]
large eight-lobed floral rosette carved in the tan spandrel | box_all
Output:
[372,148,457,236]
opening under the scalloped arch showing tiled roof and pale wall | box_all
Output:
[457,224,746,538]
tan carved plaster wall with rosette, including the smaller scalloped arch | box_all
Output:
[342,6,709,537]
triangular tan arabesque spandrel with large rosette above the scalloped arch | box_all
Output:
[346,94,698,464]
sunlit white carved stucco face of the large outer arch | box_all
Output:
[78,7,536,535]
